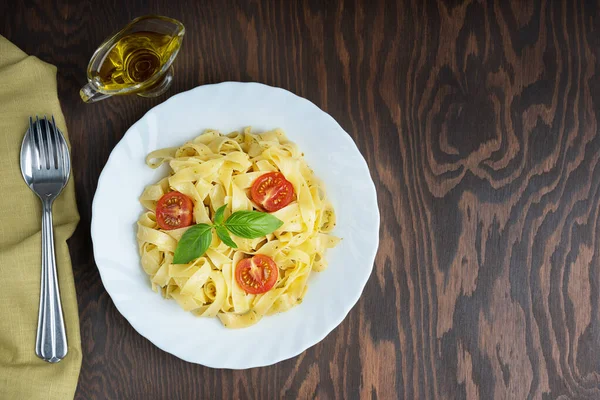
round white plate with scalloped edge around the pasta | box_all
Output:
[92,82,379,369]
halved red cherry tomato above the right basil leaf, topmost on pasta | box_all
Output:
[250,172,294,212]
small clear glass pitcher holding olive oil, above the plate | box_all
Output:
[79,15,185,103]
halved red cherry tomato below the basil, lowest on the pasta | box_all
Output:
[235,254,279,294]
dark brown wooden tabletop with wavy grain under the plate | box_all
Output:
[0,0,600,399]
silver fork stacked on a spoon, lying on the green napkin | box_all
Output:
[21,117,71,363]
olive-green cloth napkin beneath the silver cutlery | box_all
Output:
[0,36,81,400]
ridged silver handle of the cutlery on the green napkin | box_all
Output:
[35,199,67,363]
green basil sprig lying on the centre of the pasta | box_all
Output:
[173,204,283,264]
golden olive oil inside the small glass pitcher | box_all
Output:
[91,32,181,90]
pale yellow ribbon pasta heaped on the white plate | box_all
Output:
[137,128,340,328]
